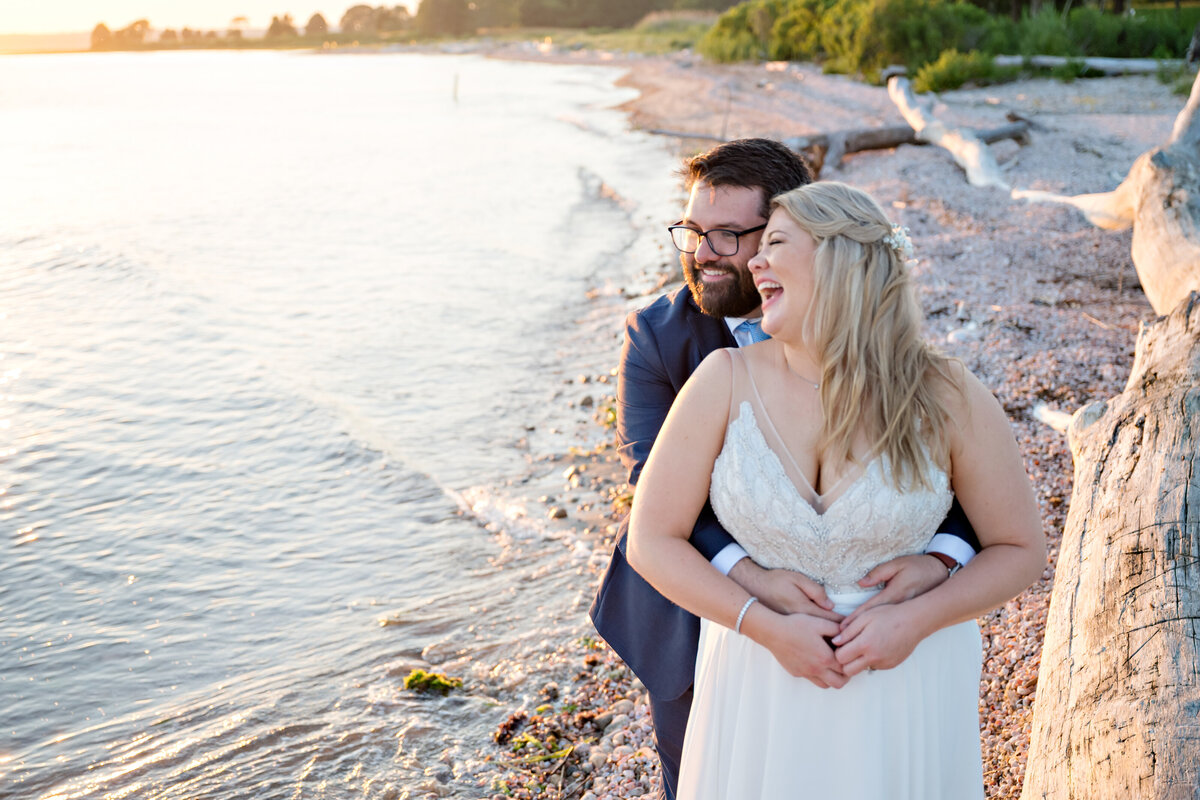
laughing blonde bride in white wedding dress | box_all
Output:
[629,182,1045,800]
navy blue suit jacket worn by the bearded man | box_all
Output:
[590,287,979,700]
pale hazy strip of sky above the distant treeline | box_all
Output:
[0,0,418,34]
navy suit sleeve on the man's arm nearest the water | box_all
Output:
[617,312,734,561]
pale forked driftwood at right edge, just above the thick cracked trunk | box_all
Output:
[1013,74,1200,314]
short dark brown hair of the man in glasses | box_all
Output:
[680,139,812,217]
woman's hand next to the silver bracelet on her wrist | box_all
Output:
[742,603,850,688]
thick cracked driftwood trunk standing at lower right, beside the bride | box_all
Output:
[1021,294,1200,800]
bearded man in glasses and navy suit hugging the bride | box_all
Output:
[590,139,978,800]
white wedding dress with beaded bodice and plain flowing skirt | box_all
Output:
[677,350,984,800]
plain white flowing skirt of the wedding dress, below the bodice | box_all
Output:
[677,593,984,800]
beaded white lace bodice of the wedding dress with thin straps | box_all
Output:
[709,354,952,593]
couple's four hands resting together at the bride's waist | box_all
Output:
[730,554,947,688]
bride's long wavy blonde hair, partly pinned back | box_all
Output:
[772,181,959,489]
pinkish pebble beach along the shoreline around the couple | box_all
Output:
[472,47,1186,800]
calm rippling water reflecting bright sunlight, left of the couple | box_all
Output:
[0,53,676,799]
